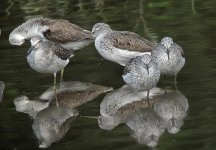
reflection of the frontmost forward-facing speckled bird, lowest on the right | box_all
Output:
[126,108,165,147]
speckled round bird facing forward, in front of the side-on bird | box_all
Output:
[122,54,160,91]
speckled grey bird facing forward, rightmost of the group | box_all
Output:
[152,37,185,76]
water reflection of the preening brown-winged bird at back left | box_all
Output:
[14,81,113,118]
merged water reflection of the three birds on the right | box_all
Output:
[98,85,188,147]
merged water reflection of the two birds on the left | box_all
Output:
[14,81,112,148]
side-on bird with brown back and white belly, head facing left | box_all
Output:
[92,23,156,66]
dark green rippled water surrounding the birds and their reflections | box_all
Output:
[0,0,216,150]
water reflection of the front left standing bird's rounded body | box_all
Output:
[32,106,78,148]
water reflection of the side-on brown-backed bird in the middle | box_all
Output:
[98,85,165,130]
